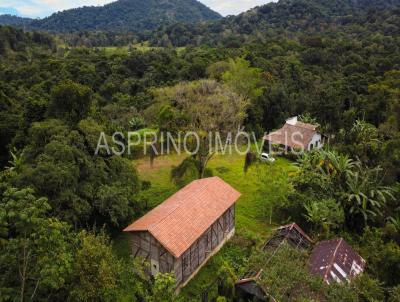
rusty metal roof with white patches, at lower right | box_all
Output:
[309,238,365,284]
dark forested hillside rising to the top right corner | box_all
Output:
[150,0,400,47]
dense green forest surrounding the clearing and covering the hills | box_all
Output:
[0,0,400,302]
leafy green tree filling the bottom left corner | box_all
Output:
[0,188,74,302]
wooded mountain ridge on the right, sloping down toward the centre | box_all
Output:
[146,0,400,47]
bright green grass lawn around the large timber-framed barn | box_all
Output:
[115,154,295,301]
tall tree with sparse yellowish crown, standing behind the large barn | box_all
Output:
[156,80,248,178]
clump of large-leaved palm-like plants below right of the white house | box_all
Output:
[298,150,394,222]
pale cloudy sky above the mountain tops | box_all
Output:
[0,0,271,18]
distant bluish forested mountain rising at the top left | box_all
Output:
[0,0,221,32]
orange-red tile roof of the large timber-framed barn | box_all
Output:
[124,177,240,258]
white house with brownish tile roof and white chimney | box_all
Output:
[264,116,325,153]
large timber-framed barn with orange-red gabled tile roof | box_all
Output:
[124,177,240,287]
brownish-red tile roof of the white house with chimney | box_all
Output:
[264,122,317,149]
